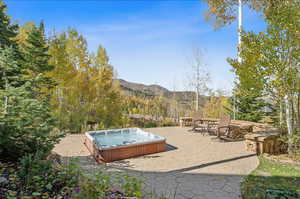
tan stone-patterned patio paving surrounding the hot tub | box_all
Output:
[54,127,258,199]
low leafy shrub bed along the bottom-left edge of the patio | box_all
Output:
[0,156,142,199]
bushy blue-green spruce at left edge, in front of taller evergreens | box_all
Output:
[0,47,60,160]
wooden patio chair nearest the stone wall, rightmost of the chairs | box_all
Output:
[208,115,231,137]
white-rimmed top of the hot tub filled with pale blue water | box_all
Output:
[87,128,164,149]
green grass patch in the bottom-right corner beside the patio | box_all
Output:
[241,157,300,199]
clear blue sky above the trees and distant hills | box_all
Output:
[4,0,265,90]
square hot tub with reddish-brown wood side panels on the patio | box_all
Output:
[84,128,166,162]
